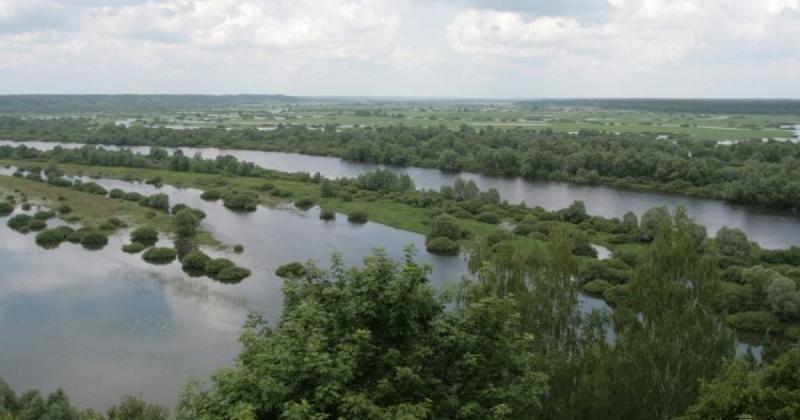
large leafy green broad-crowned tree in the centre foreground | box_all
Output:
[177,252,545,419]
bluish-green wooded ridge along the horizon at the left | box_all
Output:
[0,95,300,113]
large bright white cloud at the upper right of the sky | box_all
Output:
[447,0,800,69]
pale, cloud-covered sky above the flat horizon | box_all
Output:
[0,0,800,98]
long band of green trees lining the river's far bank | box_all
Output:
[0,117,800,209]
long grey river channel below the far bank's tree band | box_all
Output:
[0,141,800,248]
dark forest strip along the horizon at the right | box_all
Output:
[516,98,800,114]
